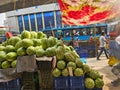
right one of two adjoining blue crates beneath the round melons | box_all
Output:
[70,76,85,90]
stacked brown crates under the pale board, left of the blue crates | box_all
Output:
[37,58,53,90]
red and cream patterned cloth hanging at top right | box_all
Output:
[58,0,120,25]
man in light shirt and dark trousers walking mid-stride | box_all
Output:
[97,32,109,60]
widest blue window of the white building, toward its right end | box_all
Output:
[44,12,55,29]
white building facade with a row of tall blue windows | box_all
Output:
[6,3,64,33]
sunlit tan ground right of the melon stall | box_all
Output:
[87,55,120,90]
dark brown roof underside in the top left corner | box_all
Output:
[0,0,57,13]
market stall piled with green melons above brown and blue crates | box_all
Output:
[0,30,104,90]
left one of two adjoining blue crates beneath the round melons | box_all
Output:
[54,76,69,90]
